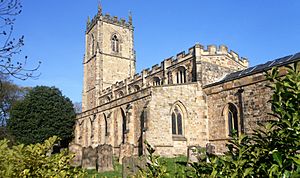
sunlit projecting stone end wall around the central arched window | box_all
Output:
[145,83,208,156]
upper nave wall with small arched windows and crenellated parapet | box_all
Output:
[95,44,248,105]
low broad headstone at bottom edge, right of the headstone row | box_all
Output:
[122,156,147,178]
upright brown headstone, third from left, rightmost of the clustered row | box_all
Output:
[97,144,114,172]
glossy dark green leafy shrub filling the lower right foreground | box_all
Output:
[138,63,300,177]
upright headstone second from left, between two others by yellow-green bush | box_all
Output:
[82,146,97,169]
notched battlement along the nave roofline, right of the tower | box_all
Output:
[96,43,248,103]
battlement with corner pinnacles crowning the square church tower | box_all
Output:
[86,5,133,32]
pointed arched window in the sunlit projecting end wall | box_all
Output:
[172,106,183,135]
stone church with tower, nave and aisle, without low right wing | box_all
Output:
[75,3,255,159]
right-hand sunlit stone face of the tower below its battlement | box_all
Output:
[100,22,135,89]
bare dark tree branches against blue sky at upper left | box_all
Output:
[0,0,40,82]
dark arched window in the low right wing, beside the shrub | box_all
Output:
[227,103,239,136]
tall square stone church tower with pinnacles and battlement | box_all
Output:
[82,4,135,111]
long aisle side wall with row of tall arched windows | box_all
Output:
[75,88,151,155]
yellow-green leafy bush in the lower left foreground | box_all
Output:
[0,136,85,178]
